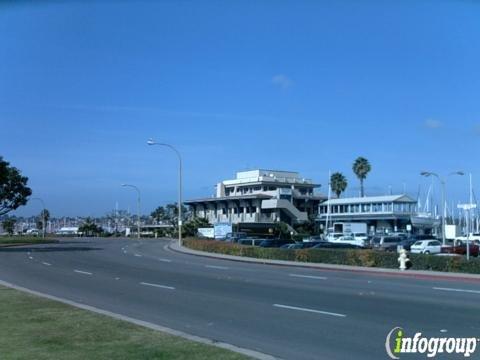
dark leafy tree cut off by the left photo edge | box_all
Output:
[0,156,32,216]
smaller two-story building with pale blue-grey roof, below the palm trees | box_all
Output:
[318,195,438,233]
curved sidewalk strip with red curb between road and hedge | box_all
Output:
[168,241,480,282]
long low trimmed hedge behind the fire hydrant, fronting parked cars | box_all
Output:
[184,238,480,274]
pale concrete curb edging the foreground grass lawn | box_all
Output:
[0,280,281,360]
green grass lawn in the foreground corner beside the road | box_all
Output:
[0,286,247,360]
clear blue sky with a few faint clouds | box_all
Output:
[0,0,480,216]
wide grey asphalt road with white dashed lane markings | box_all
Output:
[0,239,480,359]
